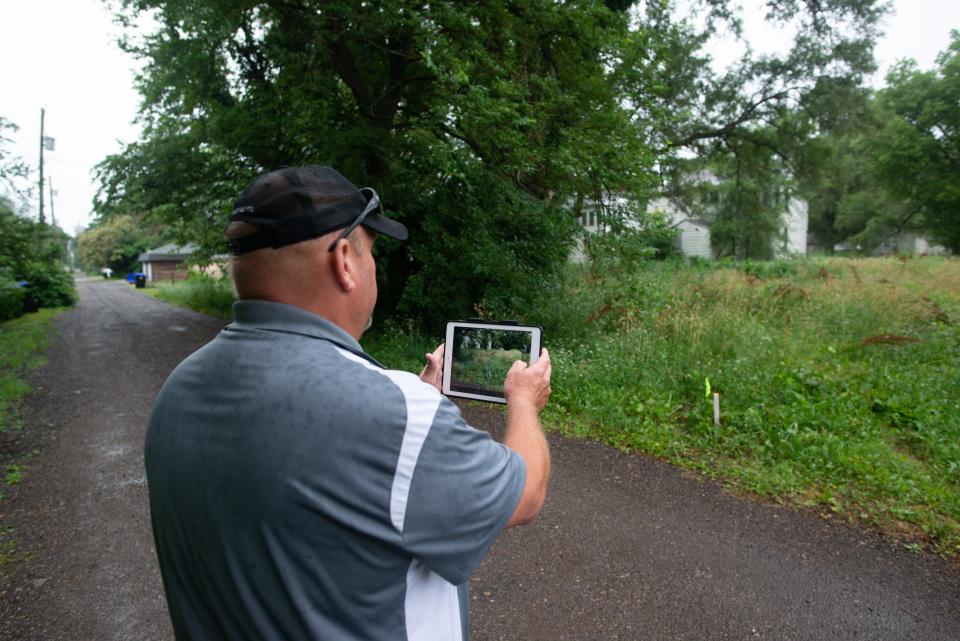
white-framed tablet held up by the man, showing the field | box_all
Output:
[443,321,543,403]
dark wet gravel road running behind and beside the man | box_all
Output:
[0,281,960,641]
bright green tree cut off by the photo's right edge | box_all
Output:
[864,31,960,252]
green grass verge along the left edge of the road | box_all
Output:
[0,309,63,432]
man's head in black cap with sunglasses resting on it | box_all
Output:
[226,166,407,338]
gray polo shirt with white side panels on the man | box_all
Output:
[145,301,526,641]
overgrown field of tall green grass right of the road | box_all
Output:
[144,257,960,556]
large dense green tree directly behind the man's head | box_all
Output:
[97,0,660,321]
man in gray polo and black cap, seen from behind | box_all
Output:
[145,167,551,641]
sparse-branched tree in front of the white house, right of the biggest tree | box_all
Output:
[648,0,885,257]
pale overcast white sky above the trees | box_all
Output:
[0,0,960,234]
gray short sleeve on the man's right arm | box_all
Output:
[402,398,526,585]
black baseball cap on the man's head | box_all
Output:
[227,165,407,256]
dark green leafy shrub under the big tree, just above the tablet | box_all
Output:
[390,166,575,327]
